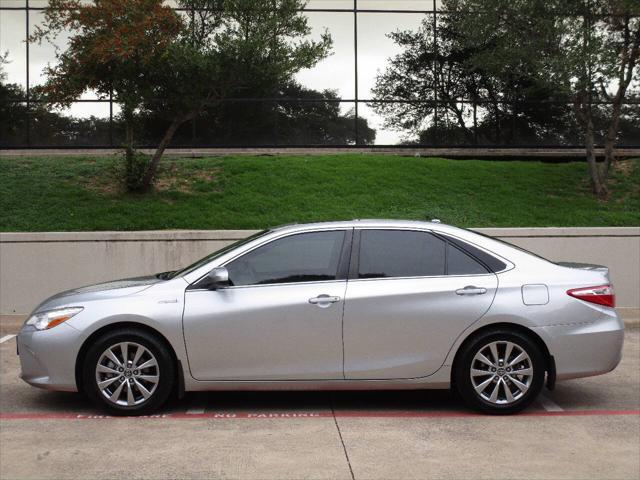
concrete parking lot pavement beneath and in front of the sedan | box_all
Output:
[0,318,640,479]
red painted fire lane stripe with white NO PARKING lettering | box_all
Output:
[0,410,640,420]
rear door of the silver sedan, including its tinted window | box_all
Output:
[343,229,498,379]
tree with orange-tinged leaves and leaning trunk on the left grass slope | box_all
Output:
[32,0,331,191]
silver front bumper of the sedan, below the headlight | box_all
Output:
[17,323,81,392]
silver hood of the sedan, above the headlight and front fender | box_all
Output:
[33,275,163,313]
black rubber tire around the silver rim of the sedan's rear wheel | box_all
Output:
[454,329,547,415]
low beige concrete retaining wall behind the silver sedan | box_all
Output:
[0,227,640,314]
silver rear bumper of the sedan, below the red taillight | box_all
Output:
[535,313,624,380]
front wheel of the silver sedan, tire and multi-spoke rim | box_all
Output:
[83,329,175,415]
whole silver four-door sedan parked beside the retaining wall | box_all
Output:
[18,220,624,415]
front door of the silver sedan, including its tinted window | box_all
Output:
[183,230,350,381]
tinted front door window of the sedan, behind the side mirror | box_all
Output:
[225,231,345,286]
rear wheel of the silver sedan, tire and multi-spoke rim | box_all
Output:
[455,330,546,414]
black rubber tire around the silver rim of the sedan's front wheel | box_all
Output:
[82,328,176,416]
